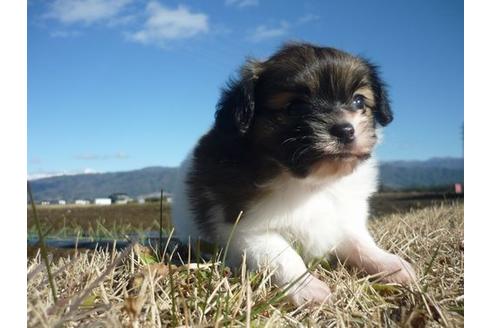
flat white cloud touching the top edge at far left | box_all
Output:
[45,0,133,24]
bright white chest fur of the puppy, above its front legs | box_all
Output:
[229,160,377,258]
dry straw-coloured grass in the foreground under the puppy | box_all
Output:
[27,202,464,327]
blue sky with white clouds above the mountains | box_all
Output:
[27,0,463,177]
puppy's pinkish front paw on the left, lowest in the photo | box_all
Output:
[288,275,331,306]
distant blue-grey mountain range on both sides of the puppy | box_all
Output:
[31,158,464,201]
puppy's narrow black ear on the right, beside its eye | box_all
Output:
[366,60,393,126]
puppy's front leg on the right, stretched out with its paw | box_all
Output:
[336,232,416,285]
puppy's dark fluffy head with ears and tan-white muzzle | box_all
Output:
[216,44,393,177]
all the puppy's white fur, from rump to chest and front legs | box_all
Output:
[172,158,415,304]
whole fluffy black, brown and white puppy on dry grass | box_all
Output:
[173,44,415,305]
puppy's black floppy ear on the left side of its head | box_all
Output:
[215,60,261,135]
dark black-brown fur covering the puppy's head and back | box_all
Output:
[187,44,393,229]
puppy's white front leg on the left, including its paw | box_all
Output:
[237,232,331,305]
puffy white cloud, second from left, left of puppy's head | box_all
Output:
[129,1,209,44]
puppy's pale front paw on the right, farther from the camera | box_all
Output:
[377,254,417,285]
